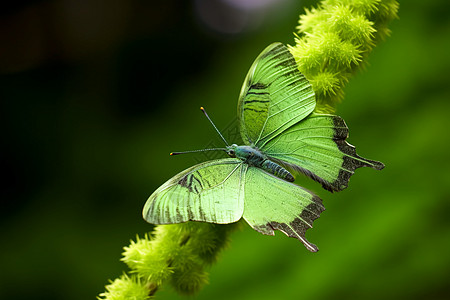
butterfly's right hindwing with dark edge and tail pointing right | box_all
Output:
[261,113,384,191]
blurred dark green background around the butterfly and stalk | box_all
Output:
[0,0,450,300]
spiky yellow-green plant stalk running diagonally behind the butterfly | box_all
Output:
[98,0,398,300]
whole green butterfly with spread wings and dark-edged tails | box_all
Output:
[143,43,384,252]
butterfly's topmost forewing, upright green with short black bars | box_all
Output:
[238,43,316,146]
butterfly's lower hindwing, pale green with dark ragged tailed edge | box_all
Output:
[243,167,325,252]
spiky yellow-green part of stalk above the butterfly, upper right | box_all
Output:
[290,0,398,113]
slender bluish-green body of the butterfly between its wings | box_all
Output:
[227,144,294,182]
